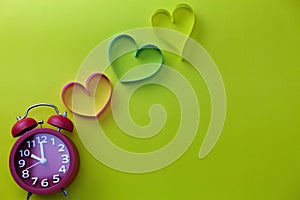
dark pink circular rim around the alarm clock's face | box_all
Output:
[9,128,79,194]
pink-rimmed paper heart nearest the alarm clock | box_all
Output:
[62,73,112,117]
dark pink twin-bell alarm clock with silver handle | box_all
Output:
[9,103,79,200]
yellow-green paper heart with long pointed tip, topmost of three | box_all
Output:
[151,4,196,55]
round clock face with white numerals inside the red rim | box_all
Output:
[14,133,70,188]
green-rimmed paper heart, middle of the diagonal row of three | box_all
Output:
[108,35,164,83]
